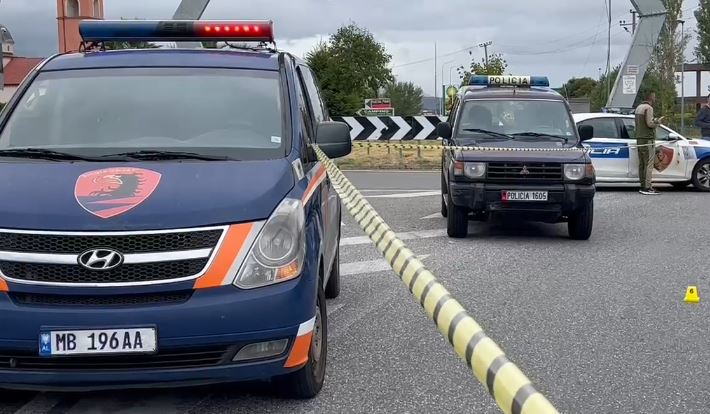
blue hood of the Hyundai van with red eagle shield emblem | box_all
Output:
[0,159,294,231]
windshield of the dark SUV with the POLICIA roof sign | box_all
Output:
[456,100,576,143]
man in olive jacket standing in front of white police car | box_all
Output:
[635,92,662,195]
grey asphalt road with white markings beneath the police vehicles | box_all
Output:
[0,172,710,414]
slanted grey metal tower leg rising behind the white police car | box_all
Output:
[606,0,668,111]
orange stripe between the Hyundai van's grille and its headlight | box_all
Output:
[195,223,254,289]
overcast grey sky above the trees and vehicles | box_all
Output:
[0,0,697,95]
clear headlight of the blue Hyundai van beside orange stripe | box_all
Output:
[234,198,306,289]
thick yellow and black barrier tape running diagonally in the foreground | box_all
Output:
[314,146,558,414]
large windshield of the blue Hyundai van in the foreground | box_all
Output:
[0,68,287,159]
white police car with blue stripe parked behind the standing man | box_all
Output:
[574,113,710,192]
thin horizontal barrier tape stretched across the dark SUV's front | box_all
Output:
[353,141,664,154]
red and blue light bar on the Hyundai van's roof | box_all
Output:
[79,20,274,43]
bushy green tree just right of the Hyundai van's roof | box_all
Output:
[306,24,394,115]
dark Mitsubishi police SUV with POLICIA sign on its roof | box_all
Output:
[437,76,596,240]
